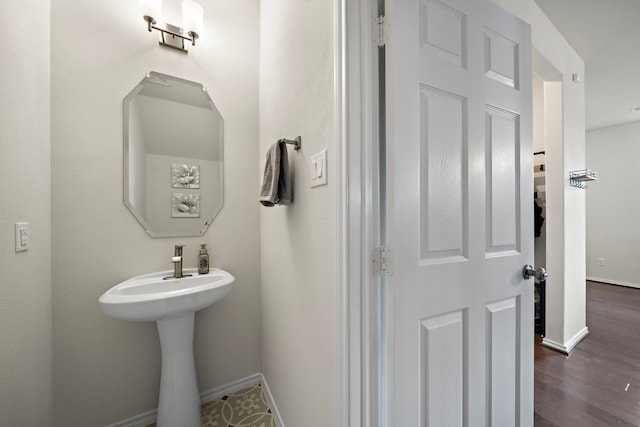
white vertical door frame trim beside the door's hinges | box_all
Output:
[334,0,384,427]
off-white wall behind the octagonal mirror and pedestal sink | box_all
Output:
[51,0,261,426]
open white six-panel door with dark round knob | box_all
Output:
[386,0,534,427]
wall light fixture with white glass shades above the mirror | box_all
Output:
[138,0,204,52]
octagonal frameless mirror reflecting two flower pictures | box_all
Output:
[124,71,224,237]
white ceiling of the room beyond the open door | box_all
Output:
[535,0,640,130]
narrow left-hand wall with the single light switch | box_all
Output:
[0,0,52,427]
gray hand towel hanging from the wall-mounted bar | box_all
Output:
[260,142,291,207]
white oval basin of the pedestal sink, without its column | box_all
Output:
[99,268,235,321]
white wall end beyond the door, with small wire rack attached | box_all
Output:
[493,0,587,350]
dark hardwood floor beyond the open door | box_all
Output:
[535,282,640,427]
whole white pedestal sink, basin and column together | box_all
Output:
[99,269,234,427]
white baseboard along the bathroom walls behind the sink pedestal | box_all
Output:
[107,373,284,427]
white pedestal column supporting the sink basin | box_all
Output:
[156,313,202,427]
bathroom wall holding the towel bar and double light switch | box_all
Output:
[259,0,336,427]
